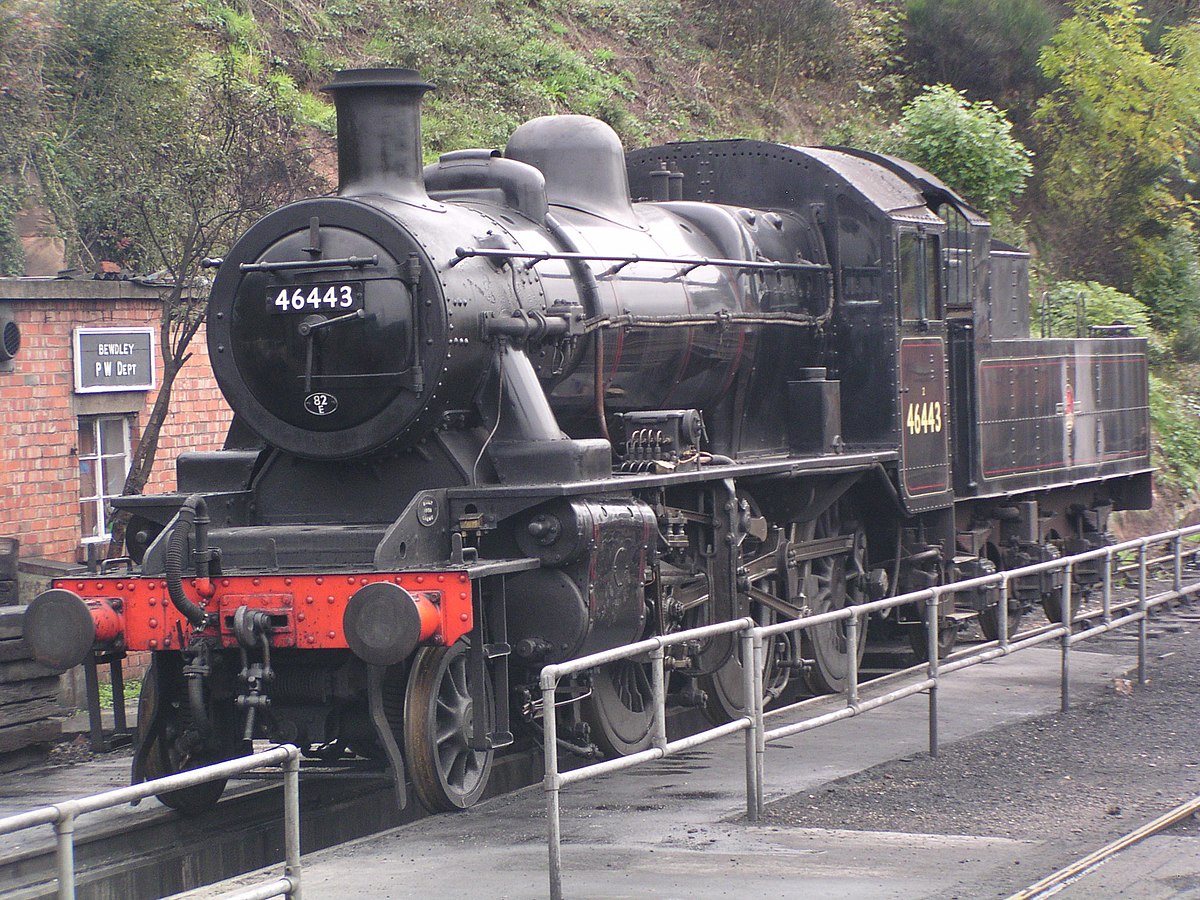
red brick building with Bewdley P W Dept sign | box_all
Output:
[0,278,232,580]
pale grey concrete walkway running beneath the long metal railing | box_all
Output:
[177,648,1152,900]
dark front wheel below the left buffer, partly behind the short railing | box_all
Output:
[137,660,238,816]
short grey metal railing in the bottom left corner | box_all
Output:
[0,744,300,900]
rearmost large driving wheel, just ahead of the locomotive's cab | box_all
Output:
[804,506,866,694]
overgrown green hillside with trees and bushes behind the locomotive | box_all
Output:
[0,0,1200,518]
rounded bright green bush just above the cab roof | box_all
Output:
[895,84,1033,218]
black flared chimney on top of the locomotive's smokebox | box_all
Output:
[323,68,433,197]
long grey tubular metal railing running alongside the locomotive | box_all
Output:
[540,526,1200,900]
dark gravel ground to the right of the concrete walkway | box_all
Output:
[764,607,1200,864]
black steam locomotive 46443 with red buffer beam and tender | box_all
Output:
[26,70,1151,810]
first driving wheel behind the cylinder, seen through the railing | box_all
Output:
[580,659,654,757]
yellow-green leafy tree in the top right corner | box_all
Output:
[1036,0,1200,288]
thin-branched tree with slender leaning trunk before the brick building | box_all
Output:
[0,0,328,550]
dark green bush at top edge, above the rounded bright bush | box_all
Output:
[905,0,1055,106]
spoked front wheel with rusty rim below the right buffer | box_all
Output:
[404,640,494,812]
